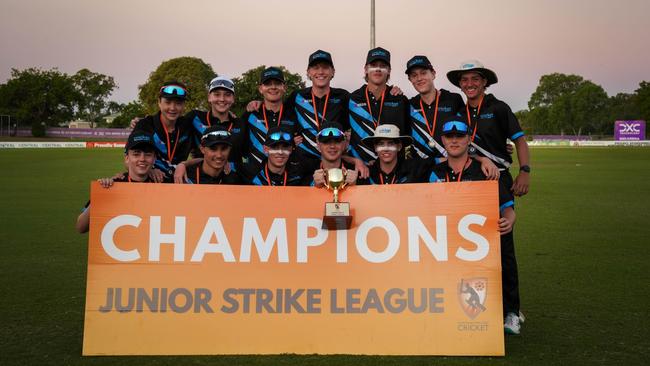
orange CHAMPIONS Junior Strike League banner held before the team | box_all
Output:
[83,182,504,355]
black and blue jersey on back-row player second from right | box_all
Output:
[409,89,465,159]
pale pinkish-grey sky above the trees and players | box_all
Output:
[0,0,650,110]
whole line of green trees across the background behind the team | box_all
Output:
[0,57,650,136]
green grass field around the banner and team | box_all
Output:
[0,148,650,365]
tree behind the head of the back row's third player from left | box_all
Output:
[232,65,305,116]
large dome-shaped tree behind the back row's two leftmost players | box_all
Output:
[139,57,215,114]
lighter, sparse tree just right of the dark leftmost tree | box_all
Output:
[72,69,117,126]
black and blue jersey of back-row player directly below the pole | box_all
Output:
[349,85,410,163]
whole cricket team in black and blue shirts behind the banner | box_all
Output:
[77,47,530,334]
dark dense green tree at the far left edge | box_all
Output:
[0,68,79,136]
